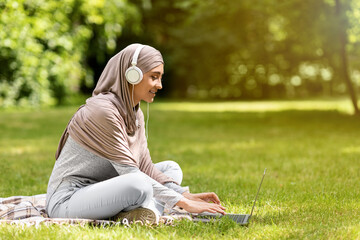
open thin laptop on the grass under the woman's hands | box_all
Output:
[192,168,266,225]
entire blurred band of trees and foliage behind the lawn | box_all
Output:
[0,0,360,113]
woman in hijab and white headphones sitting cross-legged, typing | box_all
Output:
[46,44,225,223]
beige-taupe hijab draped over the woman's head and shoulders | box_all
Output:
[55,44,164,166]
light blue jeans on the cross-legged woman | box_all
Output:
[48,161,183,219]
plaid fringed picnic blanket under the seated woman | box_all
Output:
[0,194,191,227]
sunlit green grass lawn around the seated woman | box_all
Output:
[0,100,360,239]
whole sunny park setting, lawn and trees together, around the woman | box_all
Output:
[0,0,360,239]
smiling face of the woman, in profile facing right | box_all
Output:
[130,64,164,105]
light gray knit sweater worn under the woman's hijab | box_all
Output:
[46,136,185,213]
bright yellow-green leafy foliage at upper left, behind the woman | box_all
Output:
[0,0,136,107]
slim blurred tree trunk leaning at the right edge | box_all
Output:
[335,0,360,115]
